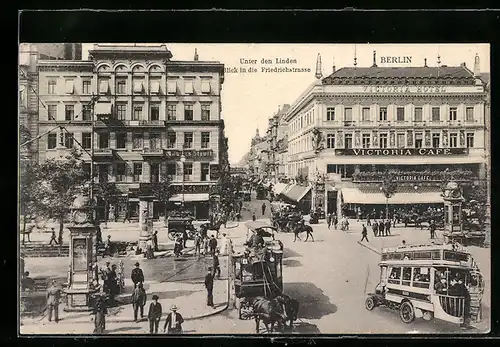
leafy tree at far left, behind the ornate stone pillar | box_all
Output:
[32,149,89,238]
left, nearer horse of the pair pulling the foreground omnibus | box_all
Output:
[250,296,287,334]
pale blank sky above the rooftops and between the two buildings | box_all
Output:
[83,43,490,163]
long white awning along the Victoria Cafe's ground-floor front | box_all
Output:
[342,187,443,205]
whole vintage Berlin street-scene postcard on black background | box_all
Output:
[18,43,491,335]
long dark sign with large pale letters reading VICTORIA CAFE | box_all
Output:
[335,148,468,157]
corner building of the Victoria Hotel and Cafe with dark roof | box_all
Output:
[285,53,487,218]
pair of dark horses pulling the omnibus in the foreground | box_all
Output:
[249,294,299,334]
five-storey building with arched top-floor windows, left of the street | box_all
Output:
[38,45,227,219]
